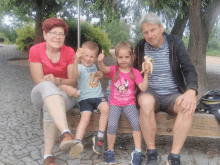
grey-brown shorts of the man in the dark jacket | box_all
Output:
[138,91,182,115]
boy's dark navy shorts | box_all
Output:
[79,97,107,113]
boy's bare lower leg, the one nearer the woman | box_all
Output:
[76,111,92,140]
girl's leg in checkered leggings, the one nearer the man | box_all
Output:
[123,105,141,152]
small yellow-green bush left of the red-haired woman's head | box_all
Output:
[15,24,35,51]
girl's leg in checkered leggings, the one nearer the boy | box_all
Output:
[107,105,121,150]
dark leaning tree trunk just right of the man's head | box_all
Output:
[170,14,189,38]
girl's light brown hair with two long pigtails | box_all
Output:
[114,41,135,81]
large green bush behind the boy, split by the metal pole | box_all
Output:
[65,20,111,55]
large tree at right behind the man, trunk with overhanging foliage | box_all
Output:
[133,0,220,96]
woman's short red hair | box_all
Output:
[43,18,68,34]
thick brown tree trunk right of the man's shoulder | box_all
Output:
[189,0,208,97]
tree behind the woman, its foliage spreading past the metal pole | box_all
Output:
[0,0,126,43]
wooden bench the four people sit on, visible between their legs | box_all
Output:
[67,108,220,138]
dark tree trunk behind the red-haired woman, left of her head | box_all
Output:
[34,10,44,44]
